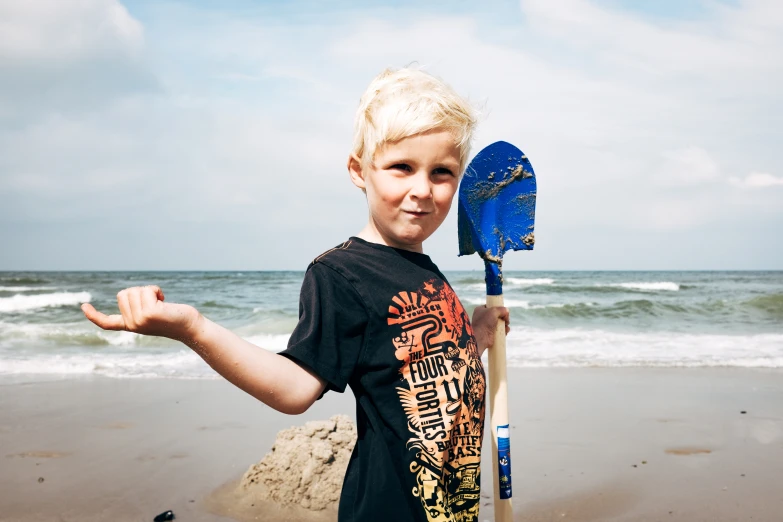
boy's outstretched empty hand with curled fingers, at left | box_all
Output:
[82,285,201,341]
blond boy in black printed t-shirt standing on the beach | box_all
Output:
[82,69,508,521]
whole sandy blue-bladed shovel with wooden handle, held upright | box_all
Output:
[458,141,536,522]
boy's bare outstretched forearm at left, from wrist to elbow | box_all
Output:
[180,314,326,415]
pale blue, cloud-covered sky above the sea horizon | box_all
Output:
[0,0,783,270]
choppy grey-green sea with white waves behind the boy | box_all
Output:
[0,271,783,379]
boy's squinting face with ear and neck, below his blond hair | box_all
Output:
[348,130,460,252]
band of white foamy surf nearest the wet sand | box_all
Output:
[0,327,783,379]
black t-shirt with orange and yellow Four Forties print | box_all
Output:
[281,237,485,522]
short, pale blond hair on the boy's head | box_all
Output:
[352,67,477,174]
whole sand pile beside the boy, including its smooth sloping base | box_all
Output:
[206,415,356,522]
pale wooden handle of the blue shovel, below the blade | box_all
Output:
[487,295,513,522]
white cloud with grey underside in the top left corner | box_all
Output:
[0,0,156,123]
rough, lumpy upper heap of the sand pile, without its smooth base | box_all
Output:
[239,415,356,511]
